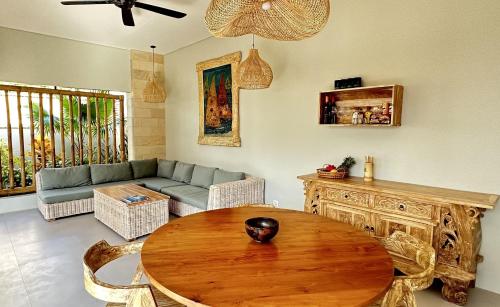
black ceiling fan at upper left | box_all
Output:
[61,0,186,27]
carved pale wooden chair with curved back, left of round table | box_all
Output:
[83,241,183,307]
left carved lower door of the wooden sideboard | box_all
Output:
[322,202,372,233]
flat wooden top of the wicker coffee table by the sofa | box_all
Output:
[95,184,170,206]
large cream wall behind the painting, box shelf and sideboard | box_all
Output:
[165,0,500,292]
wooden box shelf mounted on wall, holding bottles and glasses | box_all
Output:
[318,85,404,127]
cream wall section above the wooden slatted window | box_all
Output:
[0,27,130,92]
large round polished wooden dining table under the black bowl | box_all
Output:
[141,208,393,306]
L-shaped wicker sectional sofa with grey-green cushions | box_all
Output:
[36,159,264,220]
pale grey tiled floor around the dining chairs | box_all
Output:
[0,210,500,307]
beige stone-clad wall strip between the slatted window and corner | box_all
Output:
[128,50,166,160]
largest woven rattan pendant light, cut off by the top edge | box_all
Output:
[205,0,330,41]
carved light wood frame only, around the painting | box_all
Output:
[196,51,241,147]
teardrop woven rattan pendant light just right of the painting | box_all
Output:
[238,37,273,90]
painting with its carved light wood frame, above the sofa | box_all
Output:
[196,51,241,147]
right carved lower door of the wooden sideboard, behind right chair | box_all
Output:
[373,213,434,245]
